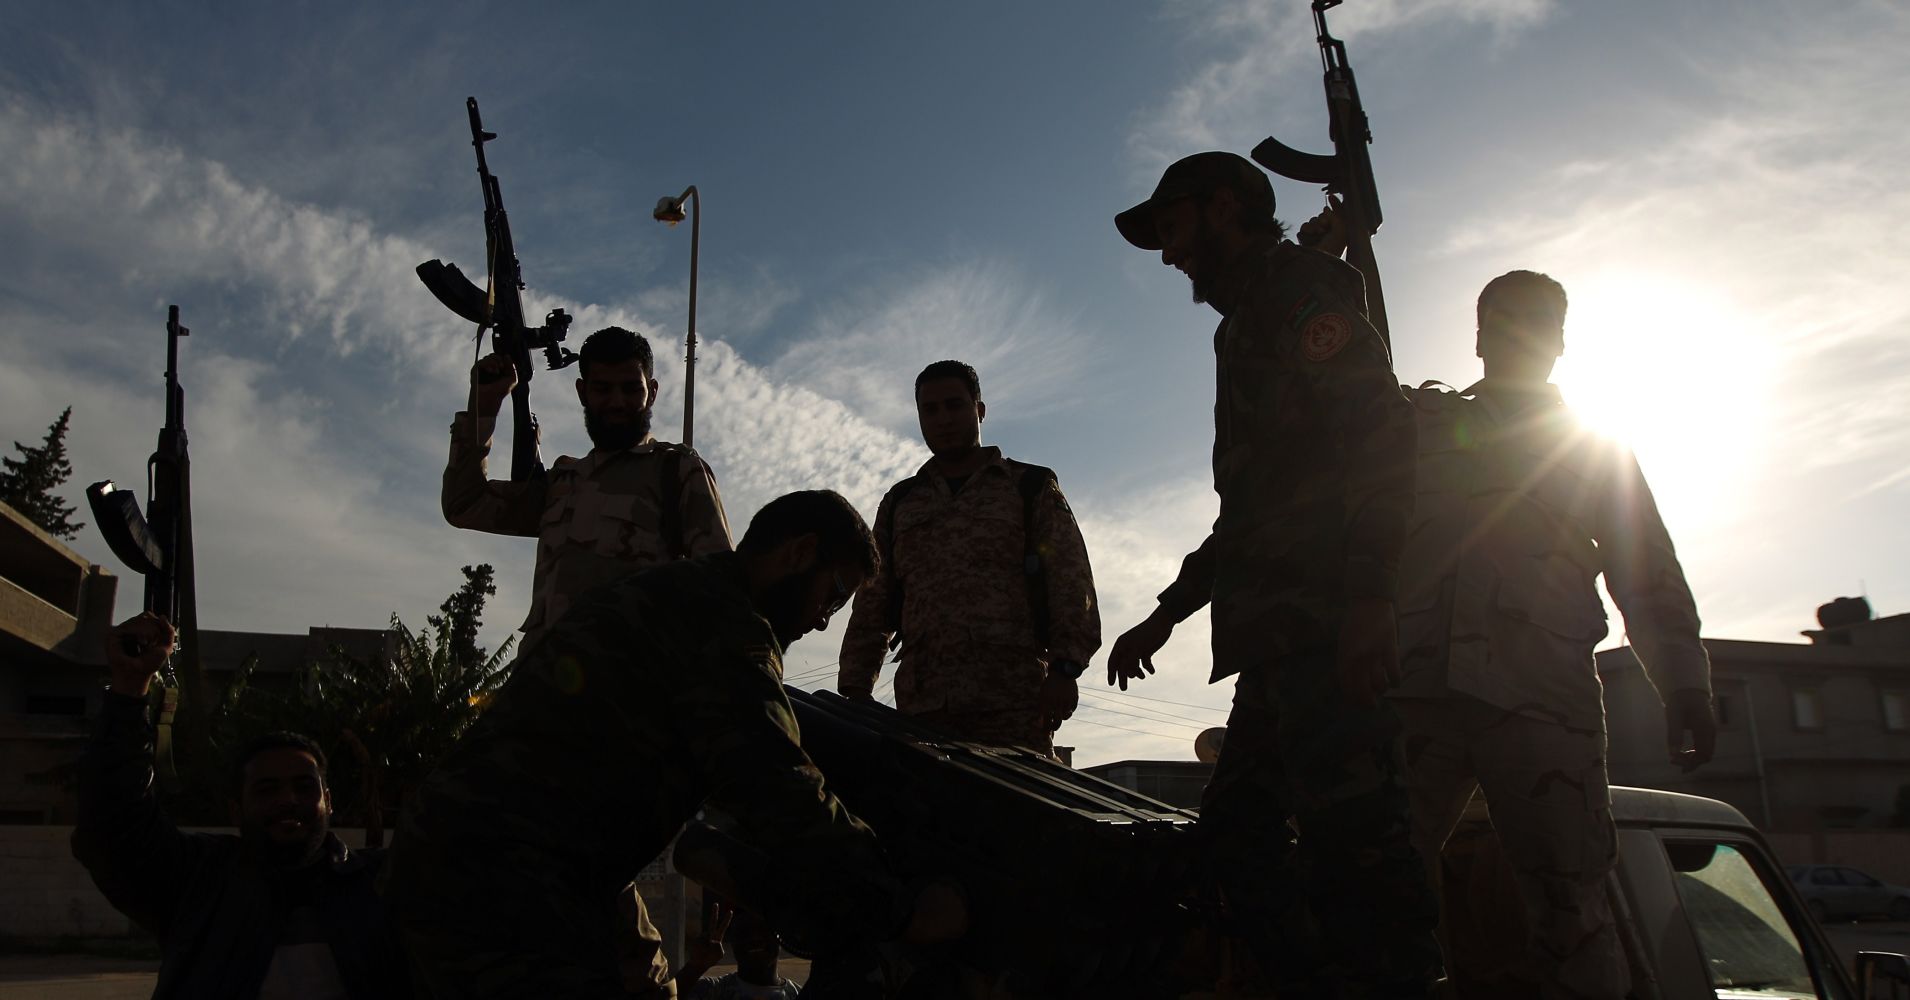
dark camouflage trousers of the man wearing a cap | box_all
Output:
[1199,653,1440,998]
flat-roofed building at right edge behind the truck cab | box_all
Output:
[1597,599,1910,834]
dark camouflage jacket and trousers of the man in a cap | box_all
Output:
[1159,239,1438,992]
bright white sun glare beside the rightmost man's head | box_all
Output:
[1555,275,1774,525]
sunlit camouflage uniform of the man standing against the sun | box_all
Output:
[1394,382,1709,998]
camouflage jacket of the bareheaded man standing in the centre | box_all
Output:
[837,448,1100,750]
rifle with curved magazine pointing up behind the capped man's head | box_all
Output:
[1253,0,1392,345]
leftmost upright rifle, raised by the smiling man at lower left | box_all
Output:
[86,305,204,782]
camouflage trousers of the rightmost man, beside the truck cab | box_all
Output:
[1394,695,1631,1000]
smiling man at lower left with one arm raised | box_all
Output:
[73,613,409,998]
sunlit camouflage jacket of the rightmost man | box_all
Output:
[1398,382,1711,729]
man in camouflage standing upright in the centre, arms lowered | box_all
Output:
[837,361,1100,754]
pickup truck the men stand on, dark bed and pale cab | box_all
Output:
[706,691,1910,1000]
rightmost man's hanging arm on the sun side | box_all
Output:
[1597,442,1717,771]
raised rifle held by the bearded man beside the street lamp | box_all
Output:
[418,97,577,481]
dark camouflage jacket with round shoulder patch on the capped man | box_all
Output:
[1159,240,1413,681]
